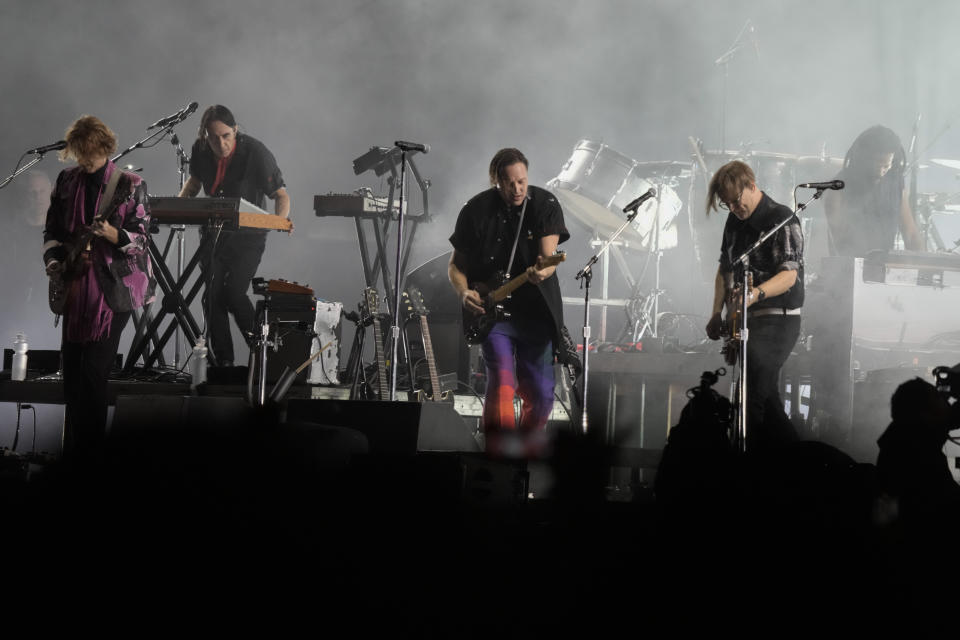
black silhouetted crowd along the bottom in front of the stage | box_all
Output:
[2,372,960,638]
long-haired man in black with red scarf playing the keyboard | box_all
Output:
[180,104,290,366]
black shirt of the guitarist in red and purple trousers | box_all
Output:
[450,186,570,331]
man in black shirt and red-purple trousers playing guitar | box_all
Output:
[448,148,570,457]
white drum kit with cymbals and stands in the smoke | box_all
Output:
[547,138,843,342]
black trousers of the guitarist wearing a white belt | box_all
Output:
[747,315,800,451]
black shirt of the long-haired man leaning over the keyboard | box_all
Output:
[190,133,285,209]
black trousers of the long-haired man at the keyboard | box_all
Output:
[201,231,267,366]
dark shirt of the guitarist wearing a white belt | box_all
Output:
[720,193,804,309]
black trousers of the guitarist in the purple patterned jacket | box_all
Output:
[61,311,131,459]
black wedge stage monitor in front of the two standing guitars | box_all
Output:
[287,399,480,455]
